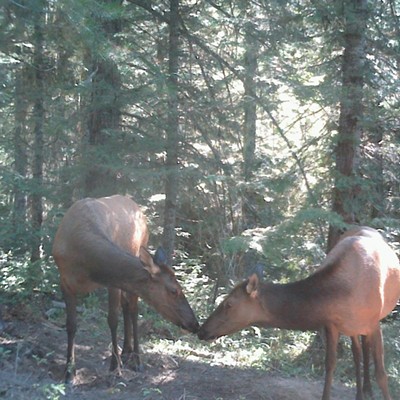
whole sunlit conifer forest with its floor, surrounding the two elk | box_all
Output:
[0,0,400,400]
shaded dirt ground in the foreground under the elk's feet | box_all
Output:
[0,308,355,400]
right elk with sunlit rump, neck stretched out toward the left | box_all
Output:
[198,227,400,400]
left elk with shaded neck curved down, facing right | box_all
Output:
[53,195,198,382]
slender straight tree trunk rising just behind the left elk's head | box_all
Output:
[163,0,179,264]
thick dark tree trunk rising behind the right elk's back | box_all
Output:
[328,0,367,250]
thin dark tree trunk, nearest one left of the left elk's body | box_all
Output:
[30,4,45,262]
